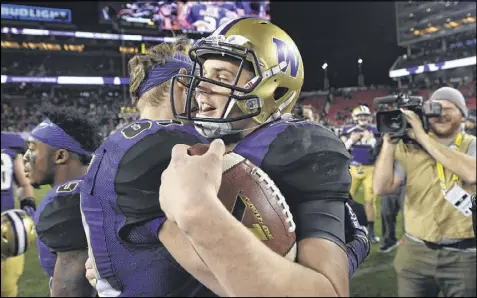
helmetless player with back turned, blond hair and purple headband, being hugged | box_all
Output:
[81,38,222,297]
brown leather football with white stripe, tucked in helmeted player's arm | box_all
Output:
[188,144,297,261]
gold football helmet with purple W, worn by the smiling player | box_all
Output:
[170,18,303,137]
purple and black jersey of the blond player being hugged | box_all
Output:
[81,120,214,297]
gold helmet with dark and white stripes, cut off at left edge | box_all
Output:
[1,209,36,259]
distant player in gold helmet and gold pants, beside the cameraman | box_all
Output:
[341,105,379,243]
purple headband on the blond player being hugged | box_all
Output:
[137,52,192,98]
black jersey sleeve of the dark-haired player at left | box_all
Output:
[36,193,88,252]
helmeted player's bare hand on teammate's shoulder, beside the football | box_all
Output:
[159,139,225,228]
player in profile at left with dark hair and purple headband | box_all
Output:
[24,108,101,297]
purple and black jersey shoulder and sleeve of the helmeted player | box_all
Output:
[234,118,351,250]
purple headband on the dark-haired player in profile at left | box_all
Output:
[30,119,91,156]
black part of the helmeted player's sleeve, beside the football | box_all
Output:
[262,127,351,251]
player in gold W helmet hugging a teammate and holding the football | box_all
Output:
[159,18,367,297]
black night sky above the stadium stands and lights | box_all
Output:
[4,1,405,91]
